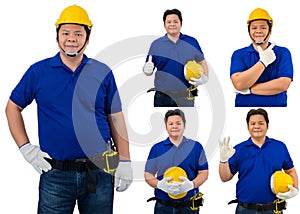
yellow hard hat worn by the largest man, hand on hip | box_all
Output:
[55,4,93,28]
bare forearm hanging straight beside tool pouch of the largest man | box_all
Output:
[108,112,130,160]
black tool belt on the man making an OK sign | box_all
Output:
[228,199,286,213]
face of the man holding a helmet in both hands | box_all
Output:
[166,115,185,139]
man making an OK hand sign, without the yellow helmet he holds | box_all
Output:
[219,108,298,214]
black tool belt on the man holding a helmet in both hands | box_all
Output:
[147,192,204,210]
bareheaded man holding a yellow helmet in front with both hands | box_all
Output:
[144,109,208,214]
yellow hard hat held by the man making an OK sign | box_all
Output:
[270,171,294,195]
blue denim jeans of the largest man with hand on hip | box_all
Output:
[38,169,114,214]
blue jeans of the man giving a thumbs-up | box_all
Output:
[154,92,194,107]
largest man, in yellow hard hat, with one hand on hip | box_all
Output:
[6,5,132,214]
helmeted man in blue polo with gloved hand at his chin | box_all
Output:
[230,8,293,107]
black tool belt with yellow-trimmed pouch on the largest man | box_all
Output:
[45,152,119,193]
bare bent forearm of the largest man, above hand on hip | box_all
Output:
[5,100,29,147]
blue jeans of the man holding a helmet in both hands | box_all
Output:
[154,201,199,214]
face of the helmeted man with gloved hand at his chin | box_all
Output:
[249,20,271,44]
